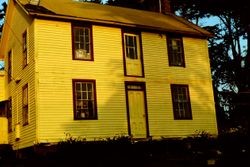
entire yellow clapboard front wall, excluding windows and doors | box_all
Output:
[35,20,217,142]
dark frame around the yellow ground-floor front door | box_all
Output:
[125,81,150,138]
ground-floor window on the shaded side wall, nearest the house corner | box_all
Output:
[22,84,29,126]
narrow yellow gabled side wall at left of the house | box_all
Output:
[4,4,36,149]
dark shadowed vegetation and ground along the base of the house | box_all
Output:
[0,131,250,167]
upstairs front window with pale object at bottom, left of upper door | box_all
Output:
[72,25,93,61]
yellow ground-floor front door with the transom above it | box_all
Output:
[126,83,148,138]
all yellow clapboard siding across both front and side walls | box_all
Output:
[0,1,217,149]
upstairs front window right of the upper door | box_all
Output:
[167,36,185,67]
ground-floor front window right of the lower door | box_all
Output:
[171,84,192,120]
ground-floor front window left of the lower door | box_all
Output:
[73,79,97,120]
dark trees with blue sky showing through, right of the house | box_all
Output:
[172,0,250,132]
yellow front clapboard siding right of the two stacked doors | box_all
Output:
[142,33,217,137]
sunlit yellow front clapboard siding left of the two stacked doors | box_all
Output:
[36,20,127,141]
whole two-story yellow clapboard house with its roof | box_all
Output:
[0,0,217,149]
